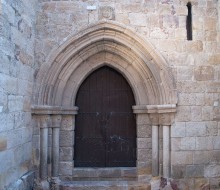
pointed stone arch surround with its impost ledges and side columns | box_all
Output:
[32,21,177,183]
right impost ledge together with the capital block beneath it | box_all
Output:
[133,104,176,125]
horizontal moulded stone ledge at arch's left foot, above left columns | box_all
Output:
[31,105,79,115]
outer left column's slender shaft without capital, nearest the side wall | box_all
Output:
[40,128,48,179]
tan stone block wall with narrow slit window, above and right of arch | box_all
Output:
[35,0,220,189]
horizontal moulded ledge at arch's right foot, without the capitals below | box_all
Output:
[132,104,176,114]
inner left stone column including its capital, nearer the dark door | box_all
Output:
[51,115,62,177]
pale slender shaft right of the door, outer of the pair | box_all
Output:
[163,126,170,178]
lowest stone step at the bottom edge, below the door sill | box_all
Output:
[60,181,151,190]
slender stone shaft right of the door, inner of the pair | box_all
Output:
[152,125,159,176]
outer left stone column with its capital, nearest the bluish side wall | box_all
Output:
[39,115,50,179]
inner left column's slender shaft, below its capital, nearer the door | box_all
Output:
[52,128,60,177]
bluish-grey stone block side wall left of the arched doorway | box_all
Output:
[0,0,37,190]
